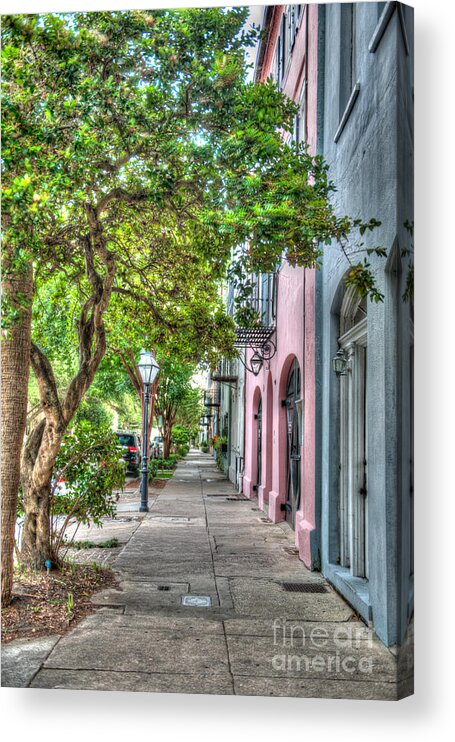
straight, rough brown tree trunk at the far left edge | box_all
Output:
[0,259,33,606]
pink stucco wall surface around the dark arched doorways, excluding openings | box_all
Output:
[243,5,318,568]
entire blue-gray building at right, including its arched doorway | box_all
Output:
[316,2,413,645]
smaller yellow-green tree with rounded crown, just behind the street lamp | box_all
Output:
[108,225,234,460]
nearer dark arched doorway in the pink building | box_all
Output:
[284,359,301,528]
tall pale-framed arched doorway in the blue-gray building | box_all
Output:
[338,288,368,578]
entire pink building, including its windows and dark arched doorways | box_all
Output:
[243,5,318,568]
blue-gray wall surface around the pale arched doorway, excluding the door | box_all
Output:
[317,3,413,645]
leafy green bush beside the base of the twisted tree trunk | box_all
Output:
[50,420,125,562]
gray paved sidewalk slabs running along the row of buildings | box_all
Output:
[2,452,412,699]
